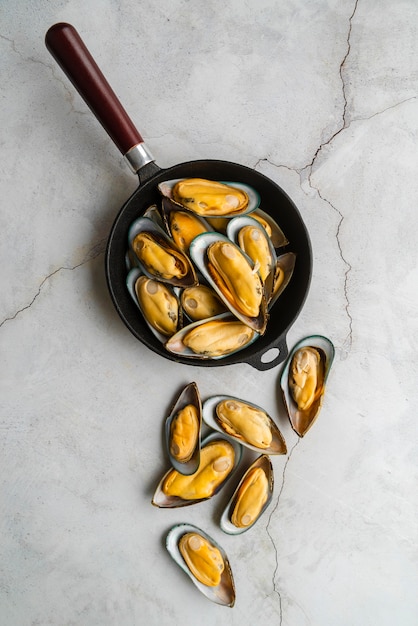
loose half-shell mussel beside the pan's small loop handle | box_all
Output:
[281,335,335,437]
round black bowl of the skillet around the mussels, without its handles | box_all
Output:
[106,160,312,367]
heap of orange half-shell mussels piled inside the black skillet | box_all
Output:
[126,178,296,359]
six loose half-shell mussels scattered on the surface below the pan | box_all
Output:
[152,335,334,607]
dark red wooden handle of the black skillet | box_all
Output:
[45,23,143,154]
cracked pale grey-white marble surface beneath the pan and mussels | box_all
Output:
[0,0,418,626]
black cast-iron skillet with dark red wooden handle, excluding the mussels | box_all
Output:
[45,23,312,370]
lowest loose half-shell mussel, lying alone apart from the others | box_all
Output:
[166,524,235,607]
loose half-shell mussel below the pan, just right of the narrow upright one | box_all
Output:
[202,395,287,454]
